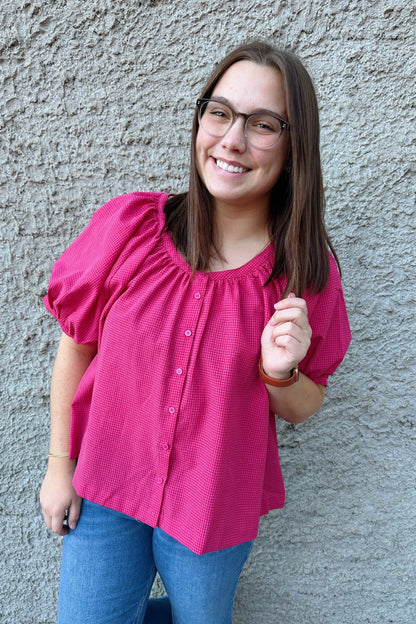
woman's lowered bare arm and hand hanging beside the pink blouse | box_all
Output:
[40,334,96,535]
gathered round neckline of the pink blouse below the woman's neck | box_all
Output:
[163,230,274,281]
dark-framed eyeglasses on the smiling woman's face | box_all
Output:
[196,98,289,149]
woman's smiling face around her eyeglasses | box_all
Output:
[196,61,289,212]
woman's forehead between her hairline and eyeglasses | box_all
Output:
[212,61,286,115]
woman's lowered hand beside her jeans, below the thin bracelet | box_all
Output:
[40,457,82,535]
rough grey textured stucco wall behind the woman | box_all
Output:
[0,0,416,624]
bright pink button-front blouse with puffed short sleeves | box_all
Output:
[44,193,350,554]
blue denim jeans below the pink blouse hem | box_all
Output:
[58,499,253,624]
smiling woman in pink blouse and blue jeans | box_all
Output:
[41,42,350,624]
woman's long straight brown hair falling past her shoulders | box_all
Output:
[165,41,340,296]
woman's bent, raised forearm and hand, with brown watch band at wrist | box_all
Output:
[261,294,325,423]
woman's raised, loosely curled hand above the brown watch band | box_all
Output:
[261,293,312,379]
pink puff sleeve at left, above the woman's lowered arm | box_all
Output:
[43,193,166,344]
